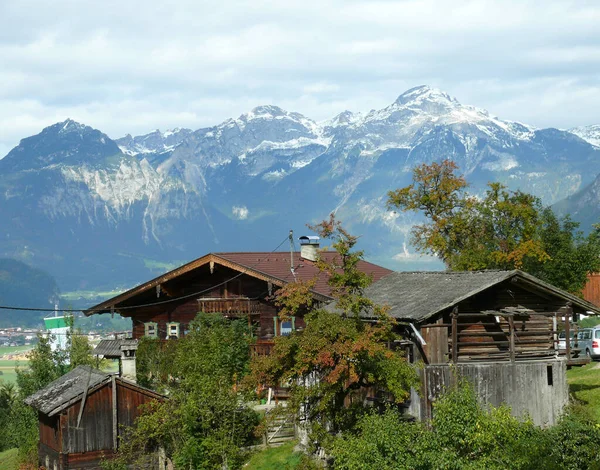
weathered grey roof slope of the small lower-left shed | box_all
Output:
[25,366,110,416]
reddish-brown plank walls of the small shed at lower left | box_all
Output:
[38,377,164,470]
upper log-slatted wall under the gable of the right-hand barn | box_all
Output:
[420,283,585,365]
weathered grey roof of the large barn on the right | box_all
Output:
[340,270,600,323]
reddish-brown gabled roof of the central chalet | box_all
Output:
[84,251,392,315]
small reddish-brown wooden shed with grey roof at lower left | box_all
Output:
[25,366,165,470]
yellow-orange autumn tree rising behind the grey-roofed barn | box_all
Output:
[388,160,549,270]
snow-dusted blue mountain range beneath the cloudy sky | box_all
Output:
[0,86,600,289]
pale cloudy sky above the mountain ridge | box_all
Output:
[0,0,600,155]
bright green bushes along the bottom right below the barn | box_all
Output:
[331,382,600,470]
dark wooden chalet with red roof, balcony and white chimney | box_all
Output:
[85,248,392,354]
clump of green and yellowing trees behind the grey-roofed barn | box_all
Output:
[388,160,600,294]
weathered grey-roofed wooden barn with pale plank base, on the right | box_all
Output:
[356,270,600,426]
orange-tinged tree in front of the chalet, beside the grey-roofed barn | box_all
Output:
[246,215,418,447]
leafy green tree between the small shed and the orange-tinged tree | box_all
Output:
[115,314,258,469]
